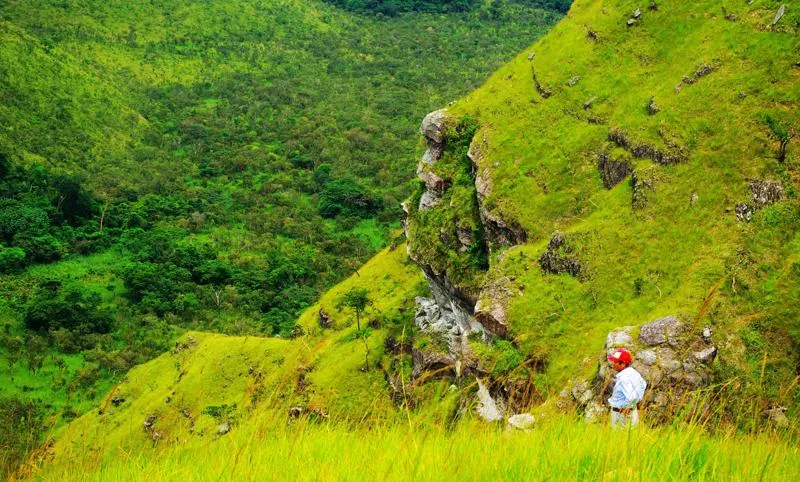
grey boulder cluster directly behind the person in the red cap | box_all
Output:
[561,316,718,422]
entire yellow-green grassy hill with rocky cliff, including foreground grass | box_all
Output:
[7,0,800,480]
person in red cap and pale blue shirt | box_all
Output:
[608,348,647,427]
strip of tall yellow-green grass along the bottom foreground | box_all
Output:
[28,416,800,481]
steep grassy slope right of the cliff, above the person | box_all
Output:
[410,0,800,405]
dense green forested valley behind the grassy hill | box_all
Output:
[0,0,559,472]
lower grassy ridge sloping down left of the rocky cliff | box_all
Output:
[32,246,424,474]
